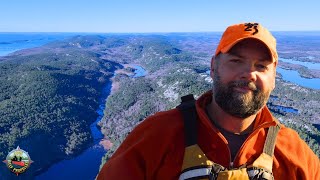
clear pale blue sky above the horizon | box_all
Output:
[0,0,320,33]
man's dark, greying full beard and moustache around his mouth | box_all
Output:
[213,72,271,118]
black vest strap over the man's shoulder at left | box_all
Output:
[177,94,198,147]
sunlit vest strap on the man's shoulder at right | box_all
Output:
[263,122,280,157]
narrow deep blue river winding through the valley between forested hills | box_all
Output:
[36,65,147,180]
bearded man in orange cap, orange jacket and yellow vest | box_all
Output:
[98,23,320,180]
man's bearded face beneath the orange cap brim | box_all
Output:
[211,39,276,118]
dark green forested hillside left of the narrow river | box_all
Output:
[0,40,121,177]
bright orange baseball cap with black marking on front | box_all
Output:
[215,23,278,61]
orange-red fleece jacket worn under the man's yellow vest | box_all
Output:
[97,92,320,180]
